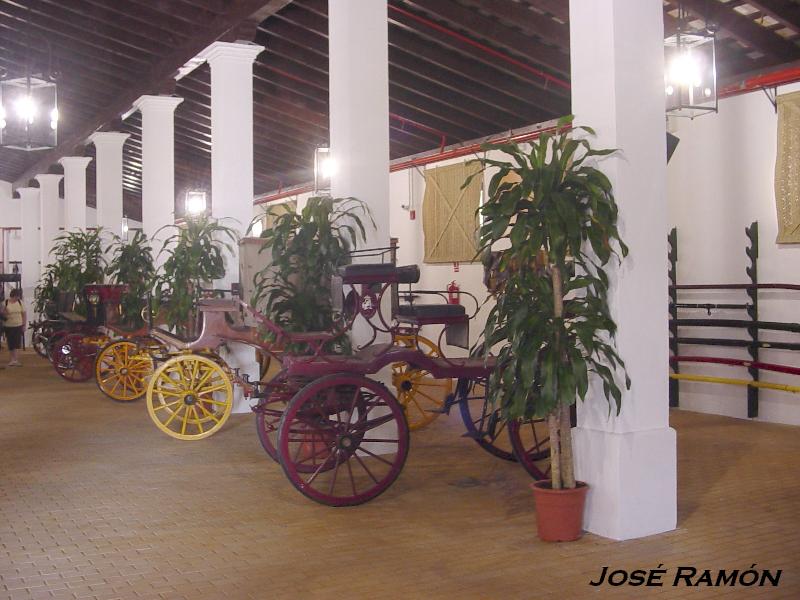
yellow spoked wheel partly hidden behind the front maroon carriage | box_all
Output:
[392,335,453,431]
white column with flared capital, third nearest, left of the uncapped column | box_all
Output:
[204,42,264,412]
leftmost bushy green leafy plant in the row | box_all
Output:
[35,228,106,312]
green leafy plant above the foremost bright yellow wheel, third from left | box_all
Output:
[156,216,237,336]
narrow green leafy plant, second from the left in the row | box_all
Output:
[106,231,156,327]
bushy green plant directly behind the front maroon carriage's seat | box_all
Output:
[252,197,375,351]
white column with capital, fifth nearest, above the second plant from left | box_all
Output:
[89,131,130,235]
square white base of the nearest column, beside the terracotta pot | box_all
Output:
[572,427,678,540]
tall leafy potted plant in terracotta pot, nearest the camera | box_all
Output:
[472,117,630,541]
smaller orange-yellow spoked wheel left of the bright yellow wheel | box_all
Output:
[94,340,153,402]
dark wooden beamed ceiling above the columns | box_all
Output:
[0,0,800,218]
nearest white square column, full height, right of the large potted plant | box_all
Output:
[570,0,677,539]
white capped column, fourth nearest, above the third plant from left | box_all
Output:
[133,96,184,253]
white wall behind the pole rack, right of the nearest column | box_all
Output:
[664,85,800,425]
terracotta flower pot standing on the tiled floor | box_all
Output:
[531,479,589,542]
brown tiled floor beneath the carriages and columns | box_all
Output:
[0,353,800,600]
